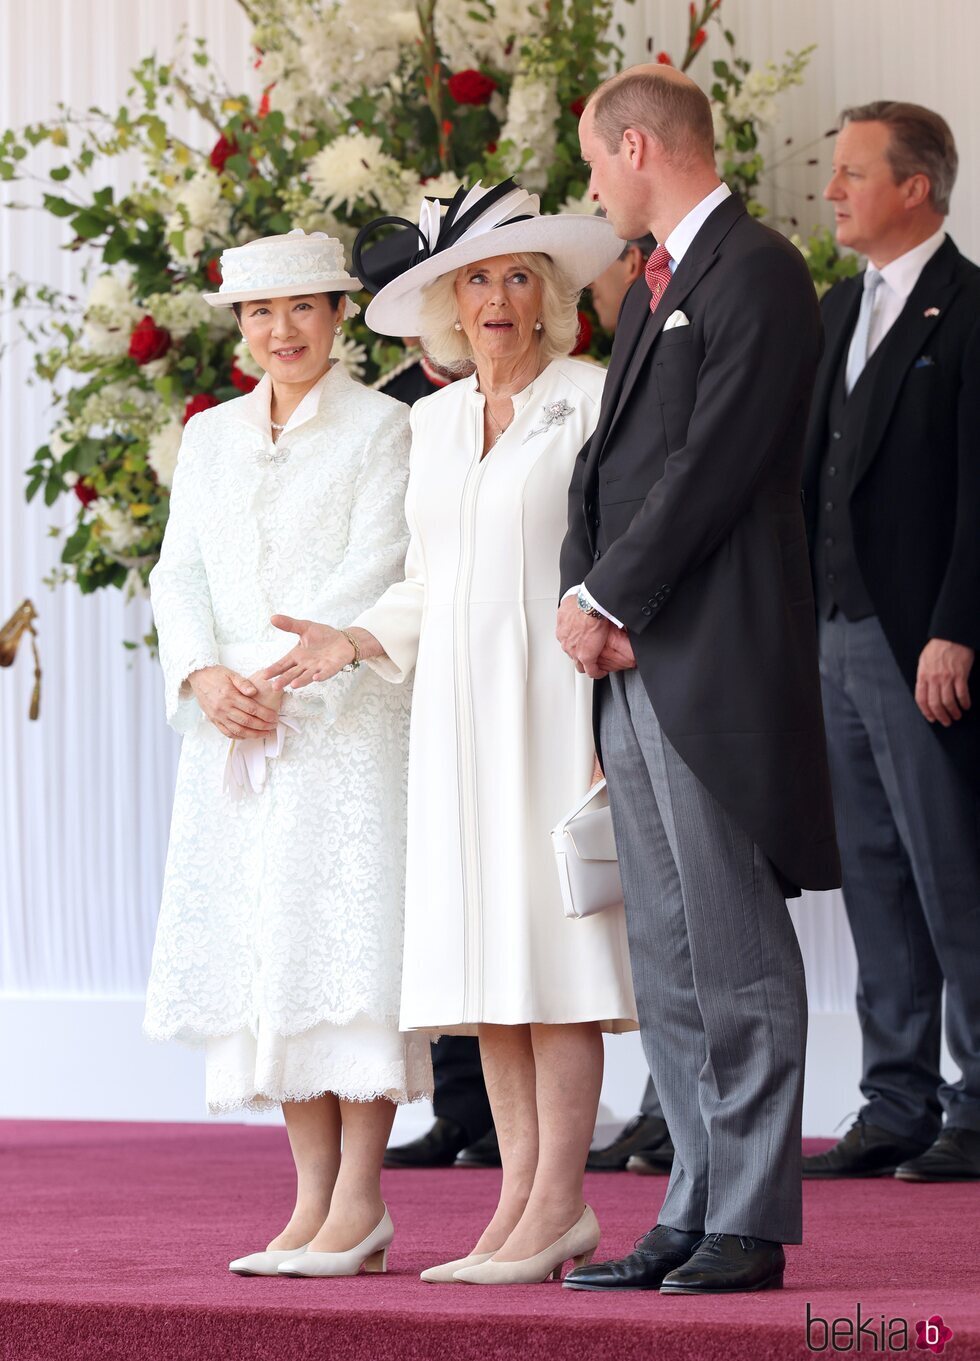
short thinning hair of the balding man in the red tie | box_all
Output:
[588,69,715,165]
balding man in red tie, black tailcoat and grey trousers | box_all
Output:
[558,67,840,1293]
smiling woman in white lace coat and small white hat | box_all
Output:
[146,233,430,1275]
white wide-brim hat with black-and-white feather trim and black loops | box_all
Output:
[353,180,623,336]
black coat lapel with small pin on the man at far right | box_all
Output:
[851,237,960,490]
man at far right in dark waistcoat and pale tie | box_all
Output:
[804,102,980,1181]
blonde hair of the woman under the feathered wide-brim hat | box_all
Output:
[419,250,581,372]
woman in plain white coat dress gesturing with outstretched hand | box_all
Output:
[265,189,636,1283]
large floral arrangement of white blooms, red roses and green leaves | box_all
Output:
[0,0,838,623]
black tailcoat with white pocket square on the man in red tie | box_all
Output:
[561,196,841,896]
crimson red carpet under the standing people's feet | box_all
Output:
[0,1121,980,1361]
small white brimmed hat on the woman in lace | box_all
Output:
[204,227,363,316]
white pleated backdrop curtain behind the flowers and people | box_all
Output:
[0,0,980,1011]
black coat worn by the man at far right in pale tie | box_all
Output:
[803,237,980,791]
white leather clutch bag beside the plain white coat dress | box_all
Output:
[551,780,623,917]
